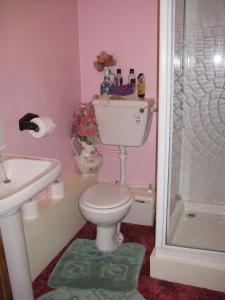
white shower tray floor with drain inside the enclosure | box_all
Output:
[168,201,225,252]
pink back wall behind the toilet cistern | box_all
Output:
[78,0,158,184]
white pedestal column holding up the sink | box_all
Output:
[0,209,34,300]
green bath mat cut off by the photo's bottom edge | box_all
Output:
[38,288,145,300]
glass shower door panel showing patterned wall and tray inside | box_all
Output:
[166,0,225,252]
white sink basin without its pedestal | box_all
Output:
[0,155,61,215]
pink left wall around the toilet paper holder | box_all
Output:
[0,0,81,177]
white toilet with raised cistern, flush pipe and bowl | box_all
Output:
[79,100,153,251]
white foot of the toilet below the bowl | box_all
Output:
[96,224,124,251]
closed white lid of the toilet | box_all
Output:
[80,183,132,208]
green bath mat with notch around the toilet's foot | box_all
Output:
[48,239,145,292]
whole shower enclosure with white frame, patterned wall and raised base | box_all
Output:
[151,0,225,291]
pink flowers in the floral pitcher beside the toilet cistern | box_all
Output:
[71,102,98,144]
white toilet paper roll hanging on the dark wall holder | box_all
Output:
[29,117,56,139]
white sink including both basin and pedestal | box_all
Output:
[0,154,61,300]
